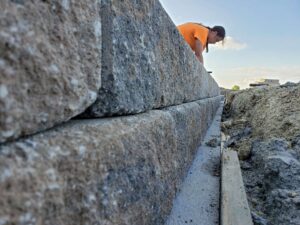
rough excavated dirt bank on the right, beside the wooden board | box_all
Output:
[222,83,300,225]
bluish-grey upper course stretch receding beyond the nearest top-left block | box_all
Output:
[85,0,219,117]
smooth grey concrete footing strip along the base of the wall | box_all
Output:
[165,101,223,225]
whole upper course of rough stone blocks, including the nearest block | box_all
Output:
[0,0,219,143]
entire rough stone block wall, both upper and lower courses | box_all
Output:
[0,0,221,225]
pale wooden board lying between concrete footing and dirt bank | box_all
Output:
[221,150,253,225]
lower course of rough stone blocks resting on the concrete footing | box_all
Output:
[0,97,220,225]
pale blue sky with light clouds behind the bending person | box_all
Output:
[160,0,300,88]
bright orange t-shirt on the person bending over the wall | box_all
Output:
[177,23,209,51]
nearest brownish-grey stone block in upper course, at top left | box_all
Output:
[0,0,101,143]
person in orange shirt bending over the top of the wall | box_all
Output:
[177,23,225,64]
